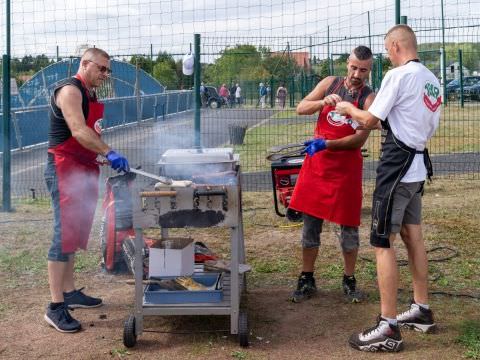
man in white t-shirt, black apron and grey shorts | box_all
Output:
[336,25,441,352]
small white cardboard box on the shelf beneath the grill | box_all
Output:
[148,238,195,277]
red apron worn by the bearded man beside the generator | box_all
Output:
[289,91,363,226]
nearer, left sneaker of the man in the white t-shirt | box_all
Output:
[348,316,403,352]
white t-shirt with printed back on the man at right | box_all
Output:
[368,61,441,182]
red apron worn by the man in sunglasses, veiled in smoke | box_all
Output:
[48,75,104,253]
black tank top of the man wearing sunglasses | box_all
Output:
[48,77,89,149]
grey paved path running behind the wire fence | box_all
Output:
[0,109,480,197]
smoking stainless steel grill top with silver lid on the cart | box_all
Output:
[134,148,241,228]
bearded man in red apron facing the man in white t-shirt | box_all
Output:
[289,46,374,302]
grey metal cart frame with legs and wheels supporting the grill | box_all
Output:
[123,167,249,347]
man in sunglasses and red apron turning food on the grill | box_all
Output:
[44,48,129,332]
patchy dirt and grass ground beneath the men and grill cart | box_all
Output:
[0,181,480,360]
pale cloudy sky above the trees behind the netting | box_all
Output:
[0,0,480,59]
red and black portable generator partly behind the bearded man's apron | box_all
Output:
[271,155,305,221]
